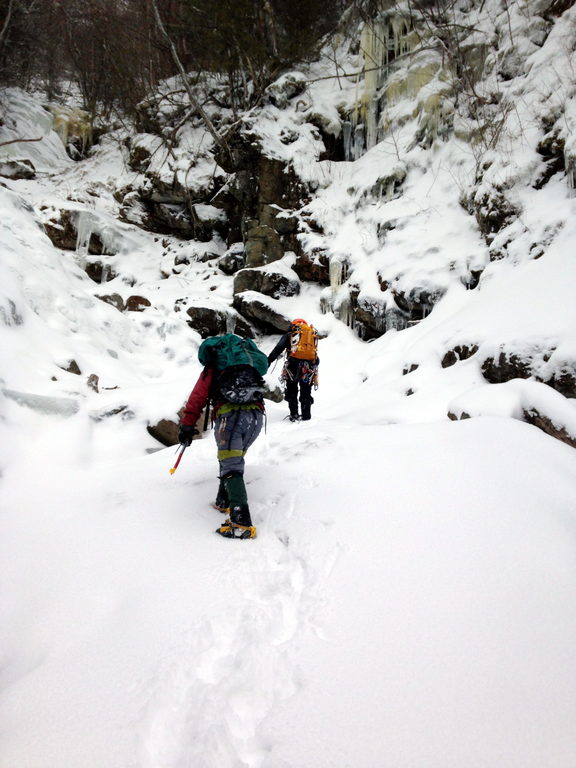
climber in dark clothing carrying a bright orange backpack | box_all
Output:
[268,318,320,421]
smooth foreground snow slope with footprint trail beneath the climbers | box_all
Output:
[0,397,576,768]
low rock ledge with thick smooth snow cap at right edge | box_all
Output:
[448,379,576,448]
